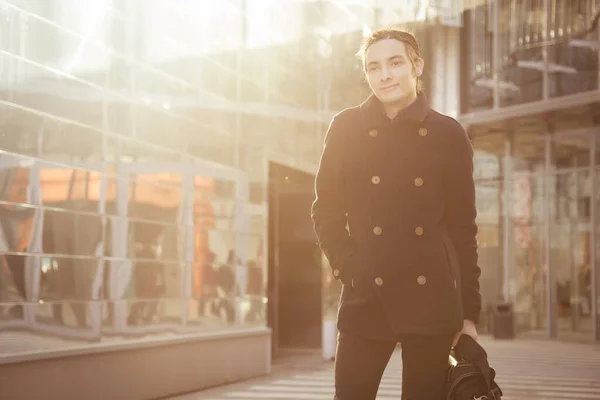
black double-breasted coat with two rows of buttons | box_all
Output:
[311,94,481,340]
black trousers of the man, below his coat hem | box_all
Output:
[334,332,453,400]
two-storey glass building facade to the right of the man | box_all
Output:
[460,0,600,341]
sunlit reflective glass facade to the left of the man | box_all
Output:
[0,0,450,357]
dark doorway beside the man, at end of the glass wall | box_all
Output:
[268,163,322,357]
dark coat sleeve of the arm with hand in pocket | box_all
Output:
[311,116,355,284]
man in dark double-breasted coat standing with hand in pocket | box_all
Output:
[312,29,481,400]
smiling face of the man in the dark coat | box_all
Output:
[366,39,423,103]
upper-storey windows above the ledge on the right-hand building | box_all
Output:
[463,0,598,113]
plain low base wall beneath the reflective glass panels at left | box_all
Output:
[0,329,270,400]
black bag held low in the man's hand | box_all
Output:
[444,335,502,400]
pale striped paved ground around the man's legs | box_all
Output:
[171,337,600,400]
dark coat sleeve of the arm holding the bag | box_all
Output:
[445,122,481,323]
